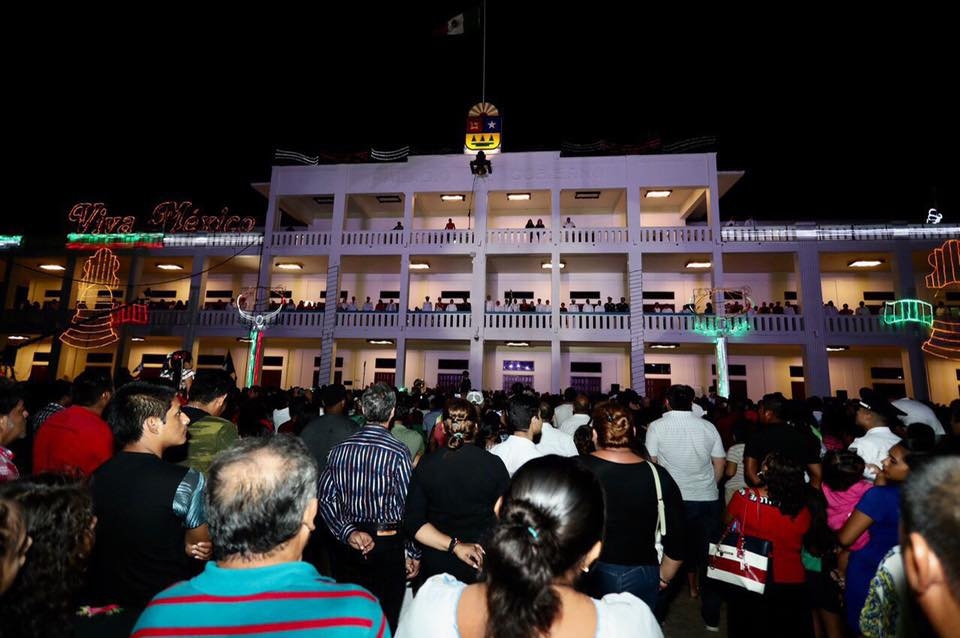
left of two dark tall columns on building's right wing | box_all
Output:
[794,248,830,397]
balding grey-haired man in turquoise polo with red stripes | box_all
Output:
[132,436,391,638]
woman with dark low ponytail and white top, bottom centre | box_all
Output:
[396,456,663,638]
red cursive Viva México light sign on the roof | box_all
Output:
[67,201,257,234]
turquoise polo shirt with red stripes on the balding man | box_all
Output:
[132,561,390,638]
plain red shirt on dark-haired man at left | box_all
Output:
[33,405,113,476]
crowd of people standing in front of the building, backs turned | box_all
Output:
[0,369,960,638]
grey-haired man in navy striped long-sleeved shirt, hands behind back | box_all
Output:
[320,383,420,630]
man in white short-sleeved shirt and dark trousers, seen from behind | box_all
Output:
[646,385,727,628]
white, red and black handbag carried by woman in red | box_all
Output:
[707,495,773,594]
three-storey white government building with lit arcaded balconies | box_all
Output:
[0,152,960,402]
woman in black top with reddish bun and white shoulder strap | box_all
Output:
[583,401,684,609]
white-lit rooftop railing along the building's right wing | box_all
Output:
[720,224,960,242]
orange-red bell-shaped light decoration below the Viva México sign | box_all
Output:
[60,248,120,350]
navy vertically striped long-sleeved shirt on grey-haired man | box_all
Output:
[320,424,420,559]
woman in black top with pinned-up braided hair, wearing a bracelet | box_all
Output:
[404,399,510,583]
